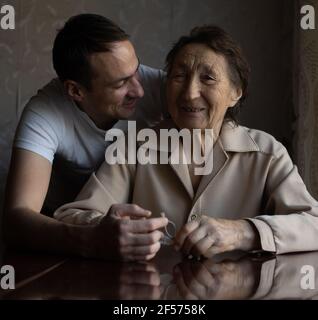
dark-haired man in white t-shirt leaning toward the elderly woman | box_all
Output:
[4,14,167,260]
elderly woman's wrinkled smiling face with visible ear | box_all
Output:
[167,44,241,129]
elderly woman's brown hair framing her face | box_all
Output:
[166,25,250,123]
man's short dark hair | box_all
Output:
[53,14,129,89]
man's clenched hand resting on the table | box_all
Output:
[84,204,168,261]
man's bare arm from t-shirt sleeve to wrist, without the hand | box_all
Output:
[3,148,86,254]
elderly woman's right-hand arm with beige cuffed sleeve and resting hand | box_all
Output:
[176,146,318,257]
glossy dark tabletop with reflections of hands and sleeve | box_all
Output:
[2,249,318,300]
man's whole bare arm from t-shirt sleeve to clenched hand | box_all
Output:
[4,149,167,261]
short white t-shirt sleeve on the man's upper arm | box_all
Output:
[13,100,61,163]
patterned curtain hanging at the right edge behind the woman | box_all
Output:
[294,0,318,199]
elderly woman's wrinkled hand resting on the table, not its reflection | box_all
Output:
[175,216,260,258]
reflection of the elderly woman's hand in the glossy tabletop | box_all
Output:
[174,258,261,300]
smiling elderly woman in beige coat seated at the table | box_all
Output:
[55,26,318,259]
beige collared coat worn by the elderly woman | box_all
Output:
[55,123,318,254]
